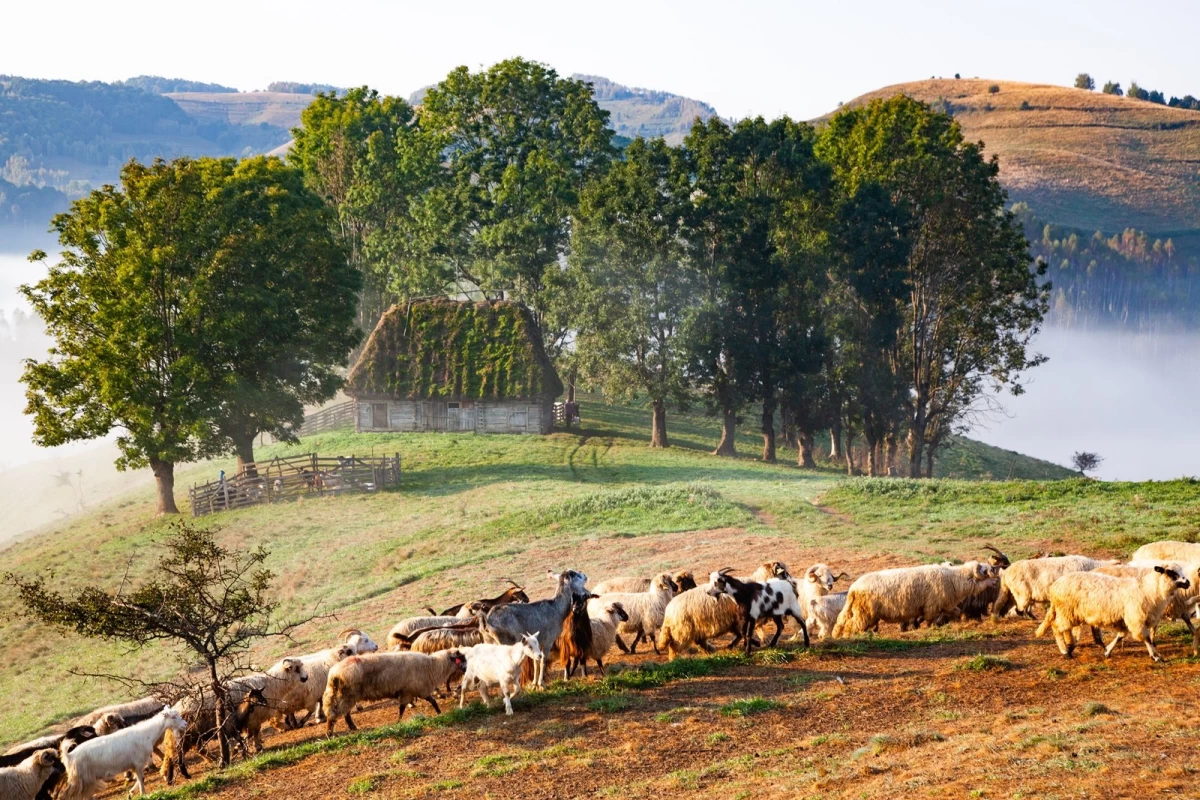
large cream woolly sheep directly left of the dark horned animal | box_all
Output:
[832,561,992,638]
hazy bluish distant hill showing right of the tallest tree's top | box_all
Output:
[572,74,716,144]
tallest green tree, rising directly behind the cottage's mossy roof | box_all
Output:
[420,59,614,331]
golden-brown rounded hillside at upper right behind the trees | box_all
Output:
[830,79,1200,233]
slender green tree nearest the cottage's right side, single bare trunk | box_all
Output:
[568,138,695,447]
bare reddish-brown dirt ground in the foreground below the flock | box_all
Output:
[117,620,1200,800]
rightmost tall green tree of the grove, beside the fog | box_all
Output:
[821,96,1049,477]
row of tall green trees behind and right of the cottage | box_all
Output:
[290,59,1049,476]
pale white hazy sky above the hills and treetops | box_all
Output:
[7,0,1200,119]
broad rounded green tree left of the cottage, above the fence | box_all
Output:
[22,158,358,513]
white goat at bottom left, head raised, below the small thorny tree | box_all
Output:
[59,705,187,800]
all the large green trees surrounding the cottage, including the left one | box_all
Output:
[23,59,1049,512]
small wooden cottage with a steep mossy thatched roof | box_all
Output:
[346,299,563,433]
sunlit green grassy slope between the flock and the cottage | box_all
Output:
[0,398,1200,758]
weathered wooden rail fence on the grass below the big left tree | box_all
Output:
[187,453,400,517]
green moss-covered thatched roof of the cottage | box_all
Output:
[346,299,563,399]
